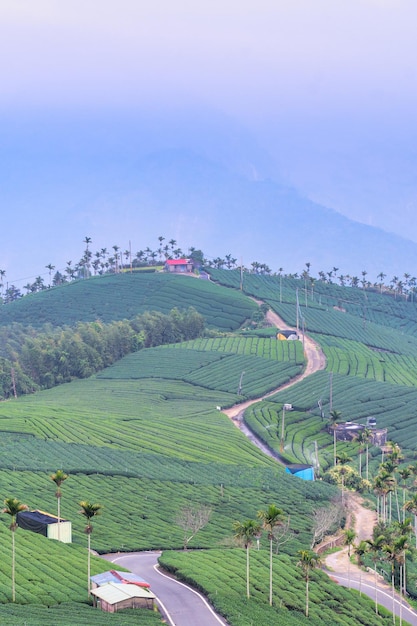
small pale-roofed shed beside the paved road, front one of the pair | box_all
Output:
[91,582,156,613]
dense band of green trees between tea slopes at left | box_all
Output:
[0,307,205,399]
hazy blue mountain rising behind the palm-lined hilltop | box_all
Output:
[0,112,417,280]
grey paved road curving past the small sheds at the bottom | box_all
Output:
[103,552,227,626]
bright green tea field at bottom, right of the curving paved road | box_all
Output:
[161,549,392,626]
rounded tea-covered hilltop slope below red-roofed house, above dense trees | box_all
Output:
[0,272,257,330]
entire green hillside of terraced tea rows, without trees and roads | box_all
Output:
[0,271,416,626]
